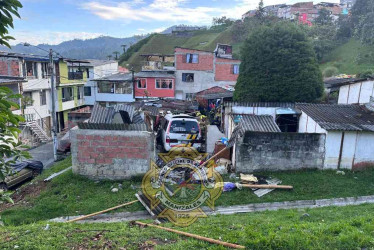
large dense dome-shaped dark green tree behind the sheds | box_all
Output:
[234,22,323,102]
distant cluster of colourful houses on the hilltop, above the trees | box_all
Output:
[242,0,356,25]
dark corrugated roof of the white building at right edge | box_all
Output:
[296,103,374,132]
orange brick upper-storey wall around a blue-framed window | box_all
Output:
[175,48,214,71]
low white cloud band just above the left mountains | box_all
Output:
[10,31,102,45]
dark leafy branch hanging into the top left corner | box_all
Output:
[0,0,22,48]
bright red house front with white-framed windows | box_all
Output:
[135,71,175,99]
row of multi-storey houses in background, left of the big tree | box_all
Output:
[0,44,240,146]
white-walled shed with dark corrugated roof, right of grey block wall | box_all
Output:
[296,103,374,170]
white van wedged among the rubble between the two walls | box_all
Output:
[160,114,202,151]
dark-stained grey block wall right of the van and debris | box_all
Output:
[235,132,325,173]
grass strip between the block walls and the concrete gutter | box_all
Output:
[0,158,374,228]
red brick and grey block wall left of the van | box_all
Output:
[71,129,155,180]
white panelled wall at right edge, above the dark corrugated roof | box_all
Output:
[338,81,374,104]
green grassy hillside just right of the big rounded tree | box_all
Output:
[321,39,374,74]
